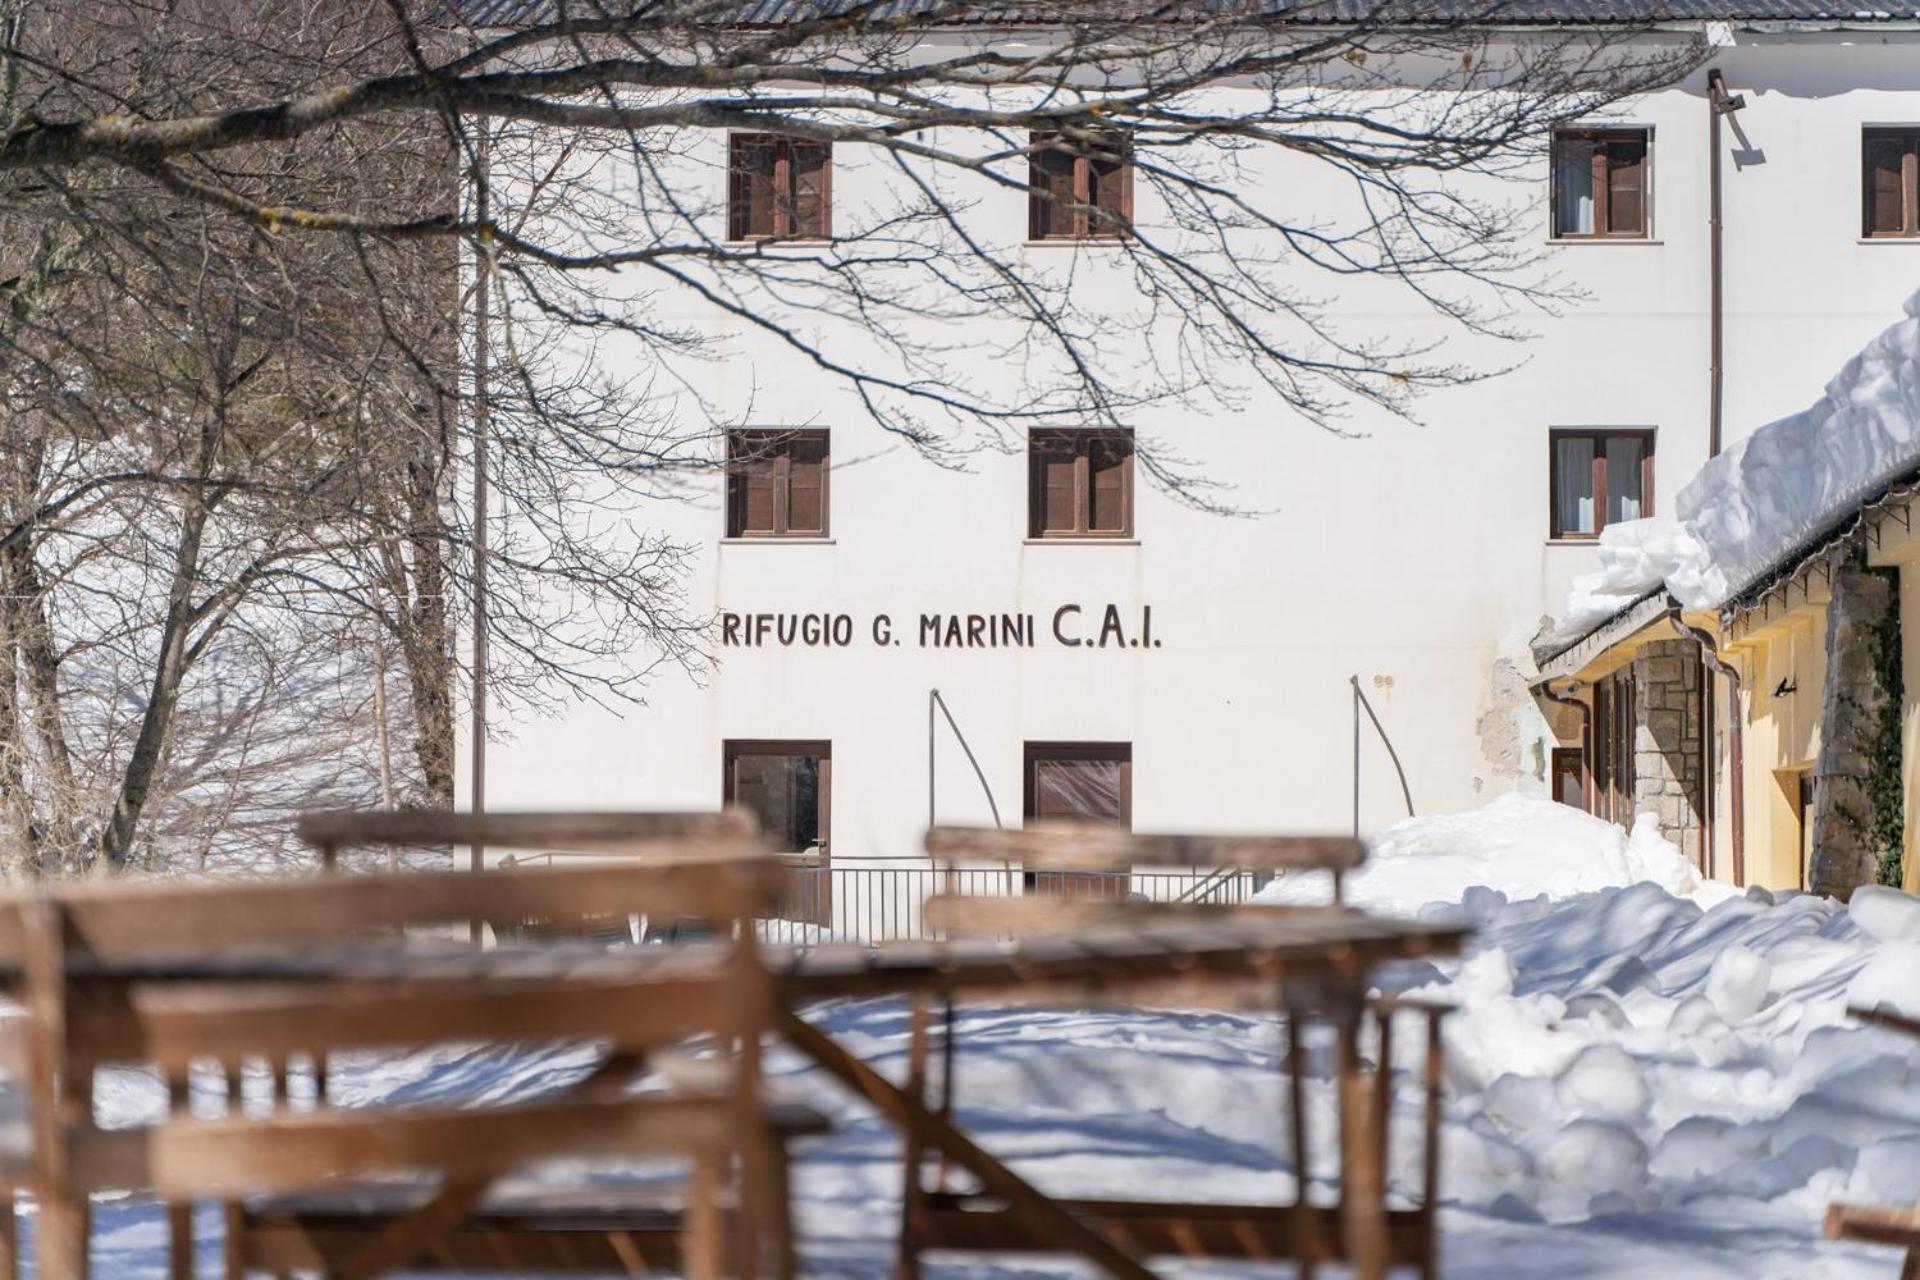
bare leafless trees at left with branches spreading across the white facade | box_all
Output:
[0,0,1701,865]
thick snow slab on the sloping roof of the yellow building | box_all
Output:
[1542,294,1920,647]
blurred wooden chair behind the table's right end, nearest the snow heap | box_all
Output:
[895,823,1444,1280]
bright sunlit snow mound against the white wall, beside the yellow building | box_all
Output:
[1256,794,1732,915]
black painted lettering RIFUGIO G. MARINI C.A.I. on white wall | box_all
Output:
[720,604,1160,649]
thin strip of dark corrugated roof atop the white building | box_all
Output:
[455,0,1920,27]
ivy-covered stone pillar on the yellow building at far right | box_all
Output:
[1809,549,1901,898]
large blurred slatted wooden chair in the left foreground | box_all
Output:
[0,814,818,1280]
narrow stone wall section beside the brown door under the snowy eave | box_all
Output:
[1634,637,1707,865]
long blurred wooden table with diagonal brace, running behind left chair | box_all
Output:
[0,912,1463,1280]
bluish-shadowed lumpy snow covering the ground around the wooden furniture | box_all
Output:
[41,800,1920,1280]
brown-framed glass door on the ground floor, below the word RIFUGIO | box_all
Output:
[722,739,833,925]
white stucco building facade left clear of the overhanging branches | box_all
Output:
[463,6,1920,901]
